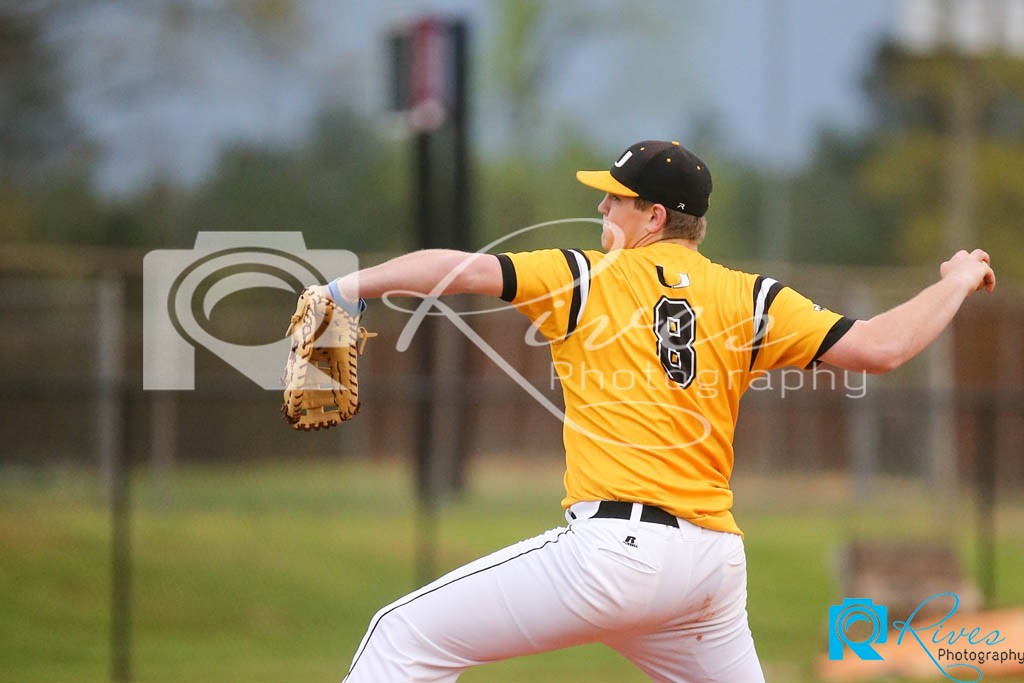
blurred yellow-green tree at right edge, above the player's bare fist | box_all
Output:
[860,43,1024,275]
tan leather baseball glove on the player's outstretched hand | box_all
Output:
[281,287,377,431]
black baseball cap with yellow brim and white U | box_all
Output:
[577,140,711,216]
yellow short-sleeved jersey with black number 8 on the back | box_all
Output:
[498,242,853,533]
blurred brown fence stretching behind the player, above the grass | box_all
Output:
[0,241,1024,490]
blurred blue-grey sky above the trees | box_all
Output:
[50,0,899,194]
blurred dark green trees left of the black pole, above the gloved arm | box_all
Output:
[132,111,411,252]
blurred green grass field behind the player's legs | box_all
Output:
[0,460,1024,683]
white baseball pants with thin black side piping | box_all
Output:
[344,502,764,683]
